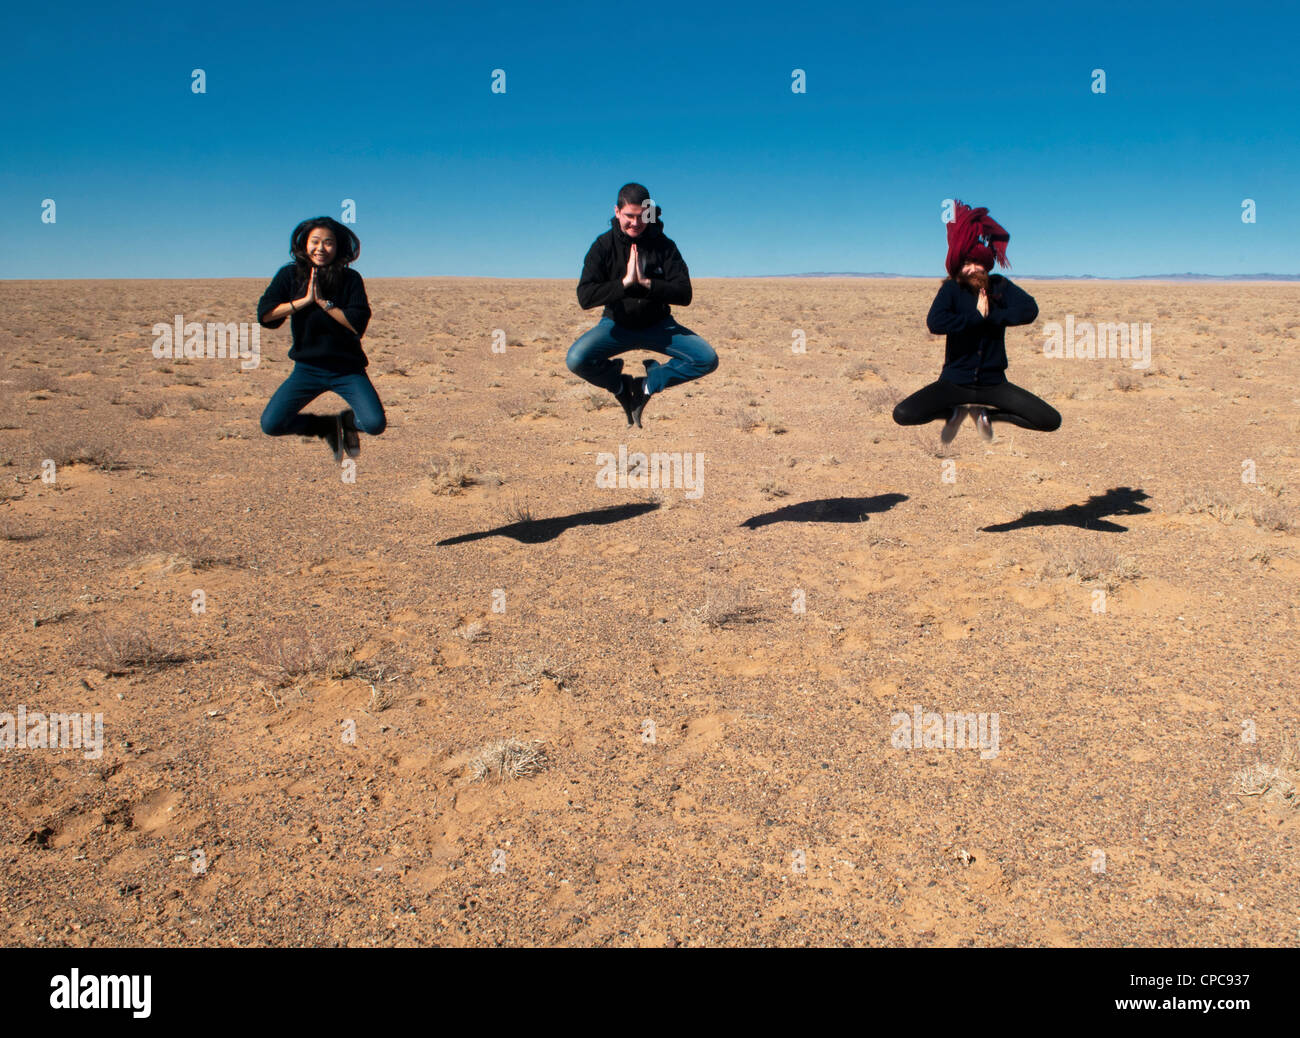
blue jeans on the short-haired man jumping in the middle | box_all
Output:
[564,316,718,394]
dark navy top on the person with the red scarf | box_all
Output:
[926,274,1039,385]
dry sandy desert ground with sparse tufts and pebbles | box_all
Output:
[0,278,1300,946]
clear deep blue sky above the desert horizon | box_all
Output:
[0,0,1300,278]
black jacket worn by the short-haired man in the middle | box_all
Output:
[577,216,690,328]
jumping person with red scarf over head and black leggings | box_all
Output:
[893,202,1061,444]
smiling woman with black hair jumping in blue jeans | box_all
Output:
[257,216,387,462]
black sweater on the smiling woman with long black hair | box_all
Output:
[257,263,371,372]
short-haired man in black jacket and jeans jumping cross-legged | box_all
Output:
[566,183,718,428]
